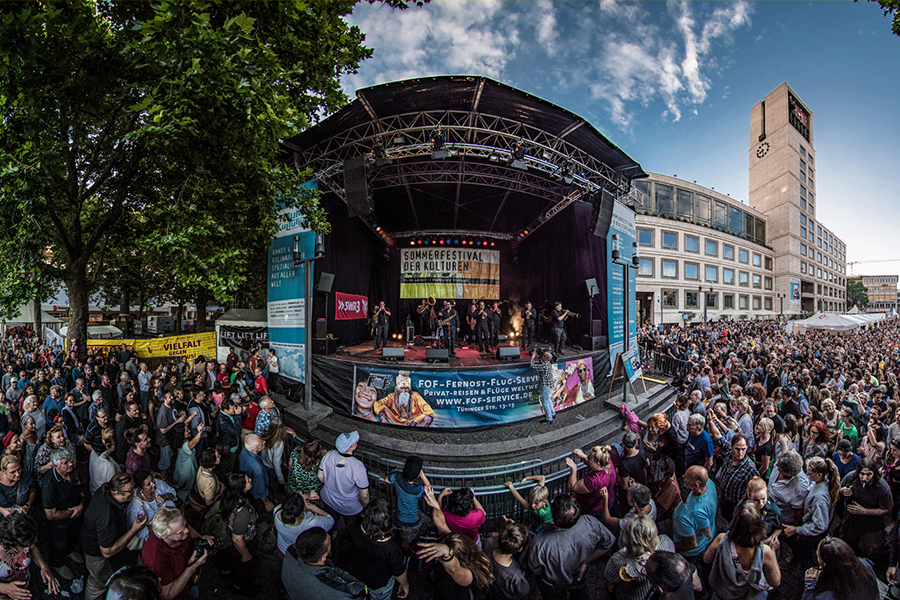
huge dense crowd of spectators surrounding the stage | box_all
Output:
[0,314,900,600]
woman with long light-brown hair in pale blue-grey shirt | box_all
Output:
[784,457,841,569]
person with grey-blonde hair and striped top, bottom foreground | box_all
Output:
[604,512,675,600]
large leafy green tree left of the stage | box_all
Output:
[0,0,422,348]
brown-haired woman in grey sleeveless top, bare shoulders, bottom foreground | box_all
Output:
[703,502,781,600]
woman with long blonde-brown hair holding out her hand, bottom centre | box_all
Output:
[416,533,494,600]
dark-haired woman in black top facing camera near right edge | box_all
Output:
[840,457,894,560]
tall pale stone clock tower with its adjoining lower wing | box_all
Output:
[749,83,848,313]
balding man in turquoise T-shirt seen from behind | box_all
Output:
[672,466,718,562]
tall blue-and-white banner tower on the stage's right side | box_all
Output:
[606,202,637,364]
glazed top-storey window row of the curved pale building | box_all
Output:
[633,180,766,244]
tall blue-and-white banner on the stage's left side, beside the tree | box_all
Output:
[266,180,317,382]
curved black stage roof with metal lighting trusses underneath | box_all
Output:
[285,76,646,240]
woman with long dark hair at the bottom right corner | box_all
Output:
[802,537,879,600]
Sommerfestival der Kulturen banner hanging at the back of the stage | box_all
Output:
[400,247,500,300]
